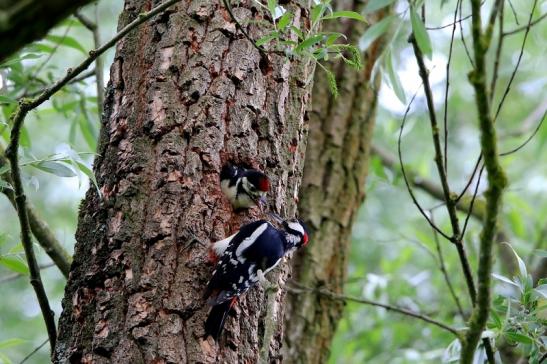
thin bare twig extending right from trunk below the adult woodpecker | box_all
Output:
[287,285,460,338]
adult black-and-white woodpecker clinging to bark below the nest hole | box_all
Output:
[204,220,308,340]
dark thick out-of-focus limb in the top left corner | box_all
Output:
[0,0,91,61]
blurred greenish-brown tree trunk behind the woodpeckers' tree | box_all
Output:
[284,1,383,363]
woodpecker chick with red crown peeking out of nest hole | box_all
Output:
[220,164,270,210]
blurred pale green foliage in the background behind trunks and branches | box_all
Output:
[0,1,547,363]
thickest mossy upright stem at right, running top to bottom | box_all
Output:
[460,0,507,364]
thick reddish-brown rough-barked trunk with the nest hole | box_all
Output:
[54,0,313,363]
